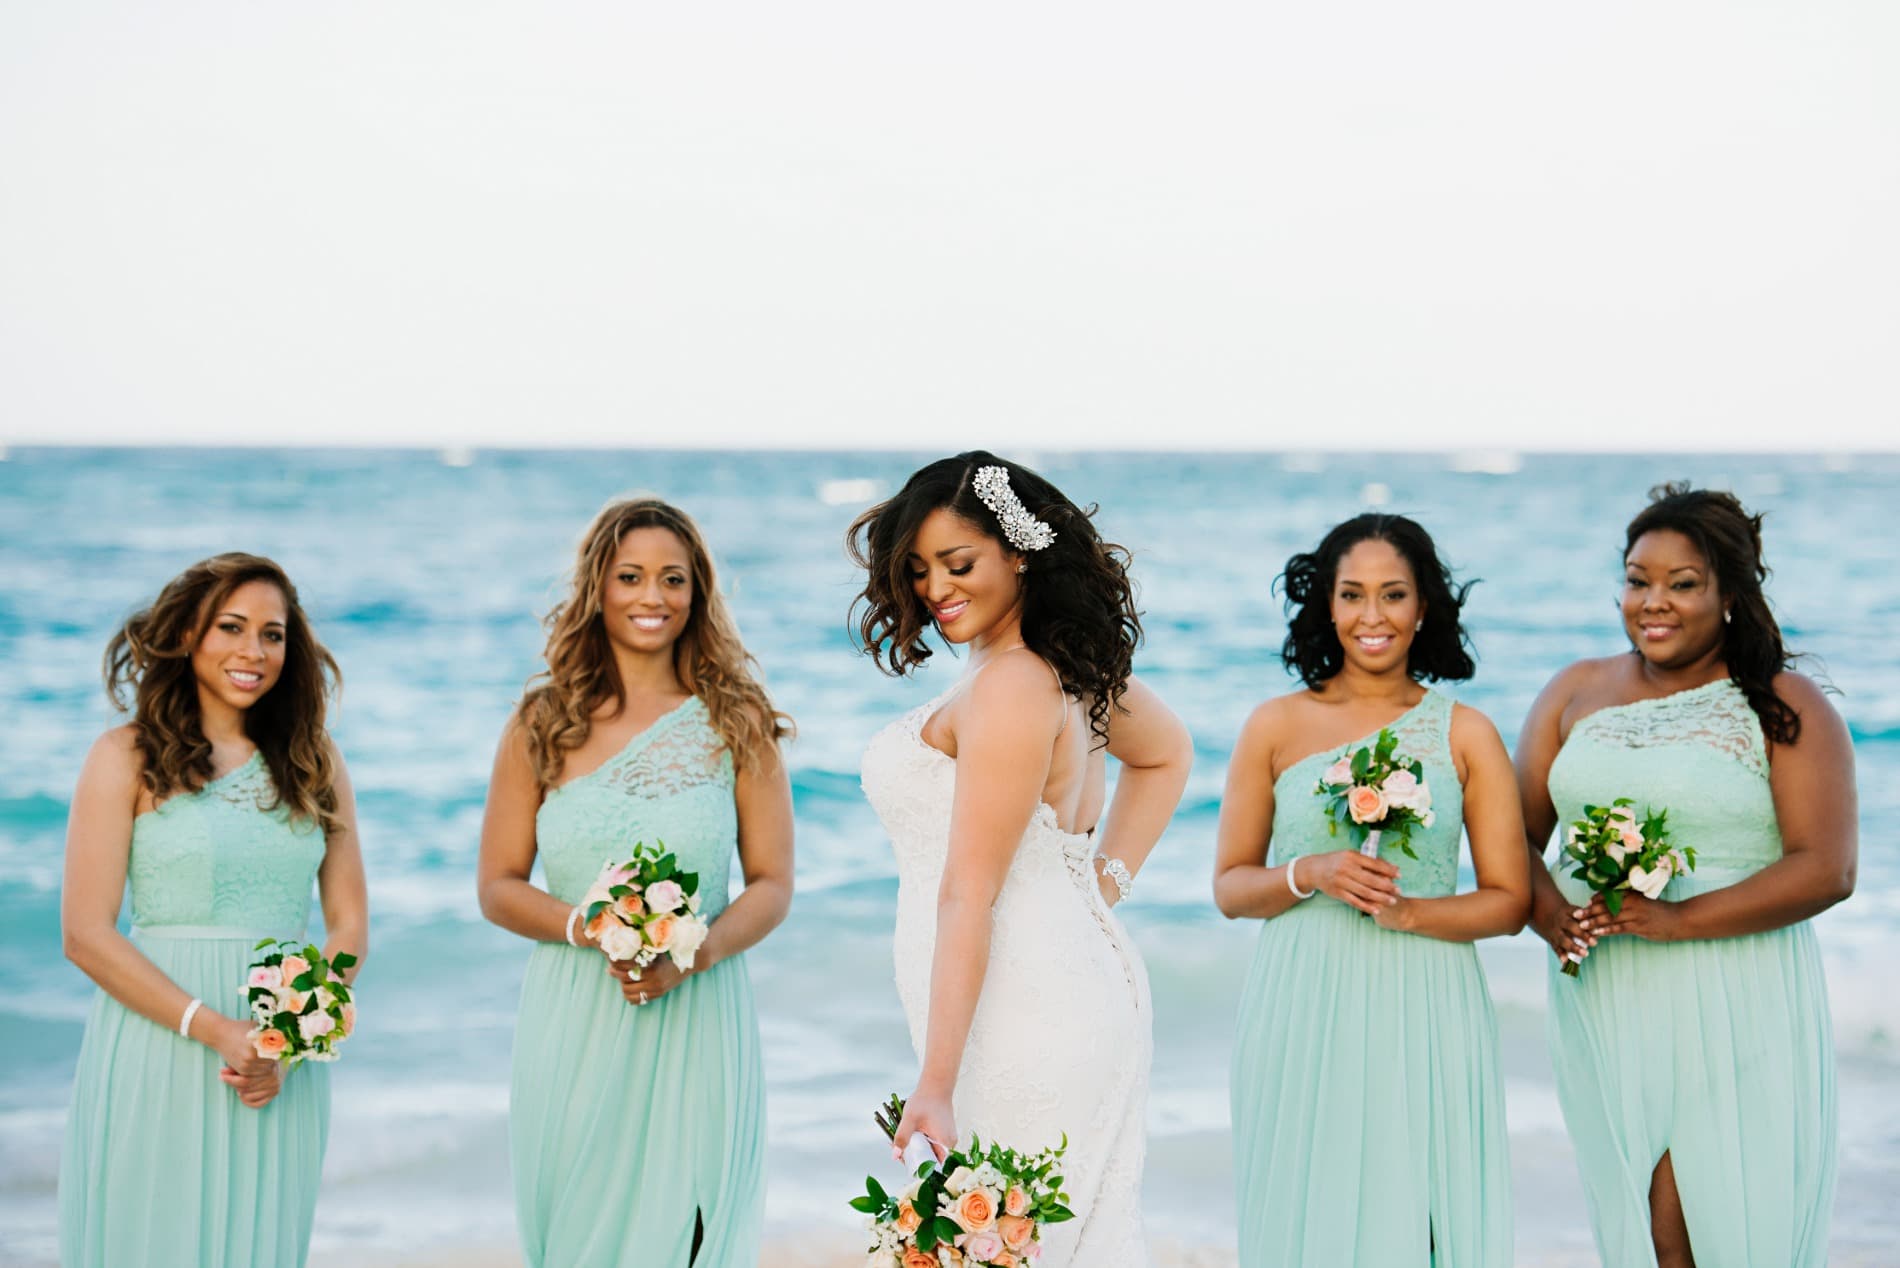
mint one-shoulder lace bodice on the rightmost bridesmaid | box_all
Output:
[1550,679,1782,897]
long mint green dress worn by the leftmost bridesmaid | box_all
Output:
[59,755,331,1268]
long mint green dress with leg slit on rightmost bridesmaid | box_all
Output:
[1549,679,1835,1268]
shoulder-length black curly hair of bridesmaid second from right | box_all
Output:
[1277,511,1478,688]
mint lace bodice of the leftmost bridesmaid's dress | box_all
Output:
[127,753,325,937]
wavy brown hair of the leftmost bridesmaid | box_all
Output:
[105,551,342,833]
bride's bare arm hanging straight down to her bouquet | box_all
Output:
[895,656,1064,1152]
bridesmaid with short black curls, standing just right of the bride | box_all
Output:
[1214,515,1530,1268]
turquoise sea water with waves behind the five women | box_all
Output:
[0,449,1900,1260]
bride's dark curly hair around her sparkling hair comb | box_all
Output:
[846,449,1142,743]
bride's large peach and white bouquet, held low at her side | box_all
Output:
[851,1097,1075,1268]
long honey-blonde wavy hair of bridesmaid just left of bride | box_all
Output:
[515,498,792,787]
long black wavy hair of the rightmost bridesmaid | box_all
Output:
[1623,483,1801,743]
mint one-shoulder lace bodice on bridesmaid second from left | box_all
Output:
[534,696,739,920]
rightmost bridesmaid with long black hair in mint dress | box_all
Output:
[1516,485,1858,1268]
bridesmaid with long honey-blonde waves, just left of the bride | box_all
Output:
[481,498,792,1268]
